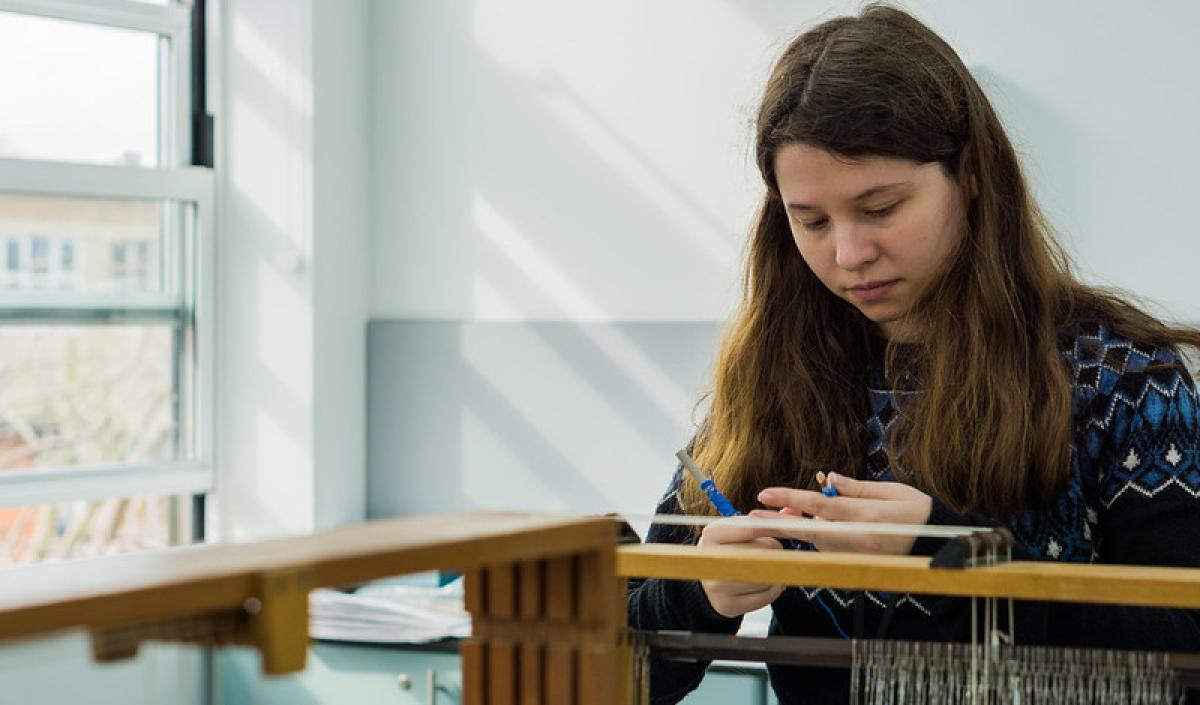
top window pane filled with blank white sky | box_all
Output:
[0,12,161,167]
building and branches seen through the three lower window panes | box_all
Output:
[0,194,178,565]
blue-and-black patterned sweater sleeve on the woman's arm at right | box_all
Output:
[914,351,1200,652]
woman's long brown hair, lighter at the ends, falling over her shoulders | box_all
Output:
[683,5,1200,517]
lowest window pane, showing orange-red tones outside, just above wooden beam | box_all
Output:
[0,496,173,566]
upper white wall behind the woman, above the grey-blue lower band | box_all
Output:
[371,0,1200,321]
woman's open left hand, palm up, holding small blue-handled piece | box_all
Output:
[750,474,934,555]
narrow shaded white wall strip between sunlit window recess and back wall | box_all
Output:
[312,0,371,529]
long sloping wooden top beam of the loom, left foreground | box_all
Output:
[0,512,616,640]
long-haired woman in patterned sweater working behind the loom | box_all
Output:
[629,6,1200,704]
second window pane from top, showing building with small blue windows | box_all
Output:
[0,193,174,294]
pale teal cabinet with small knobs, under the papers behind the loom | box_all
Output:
[212,641,775,705]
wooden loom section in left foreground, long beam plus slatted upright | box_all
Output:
[0,512,629,705]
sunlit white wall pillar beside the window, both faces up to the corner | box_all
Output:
[212,0,368,540]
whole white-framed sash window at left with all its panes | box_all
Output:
[0,0,214,565]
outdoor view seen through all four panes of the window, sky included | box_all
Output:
[0,5,182,566]
